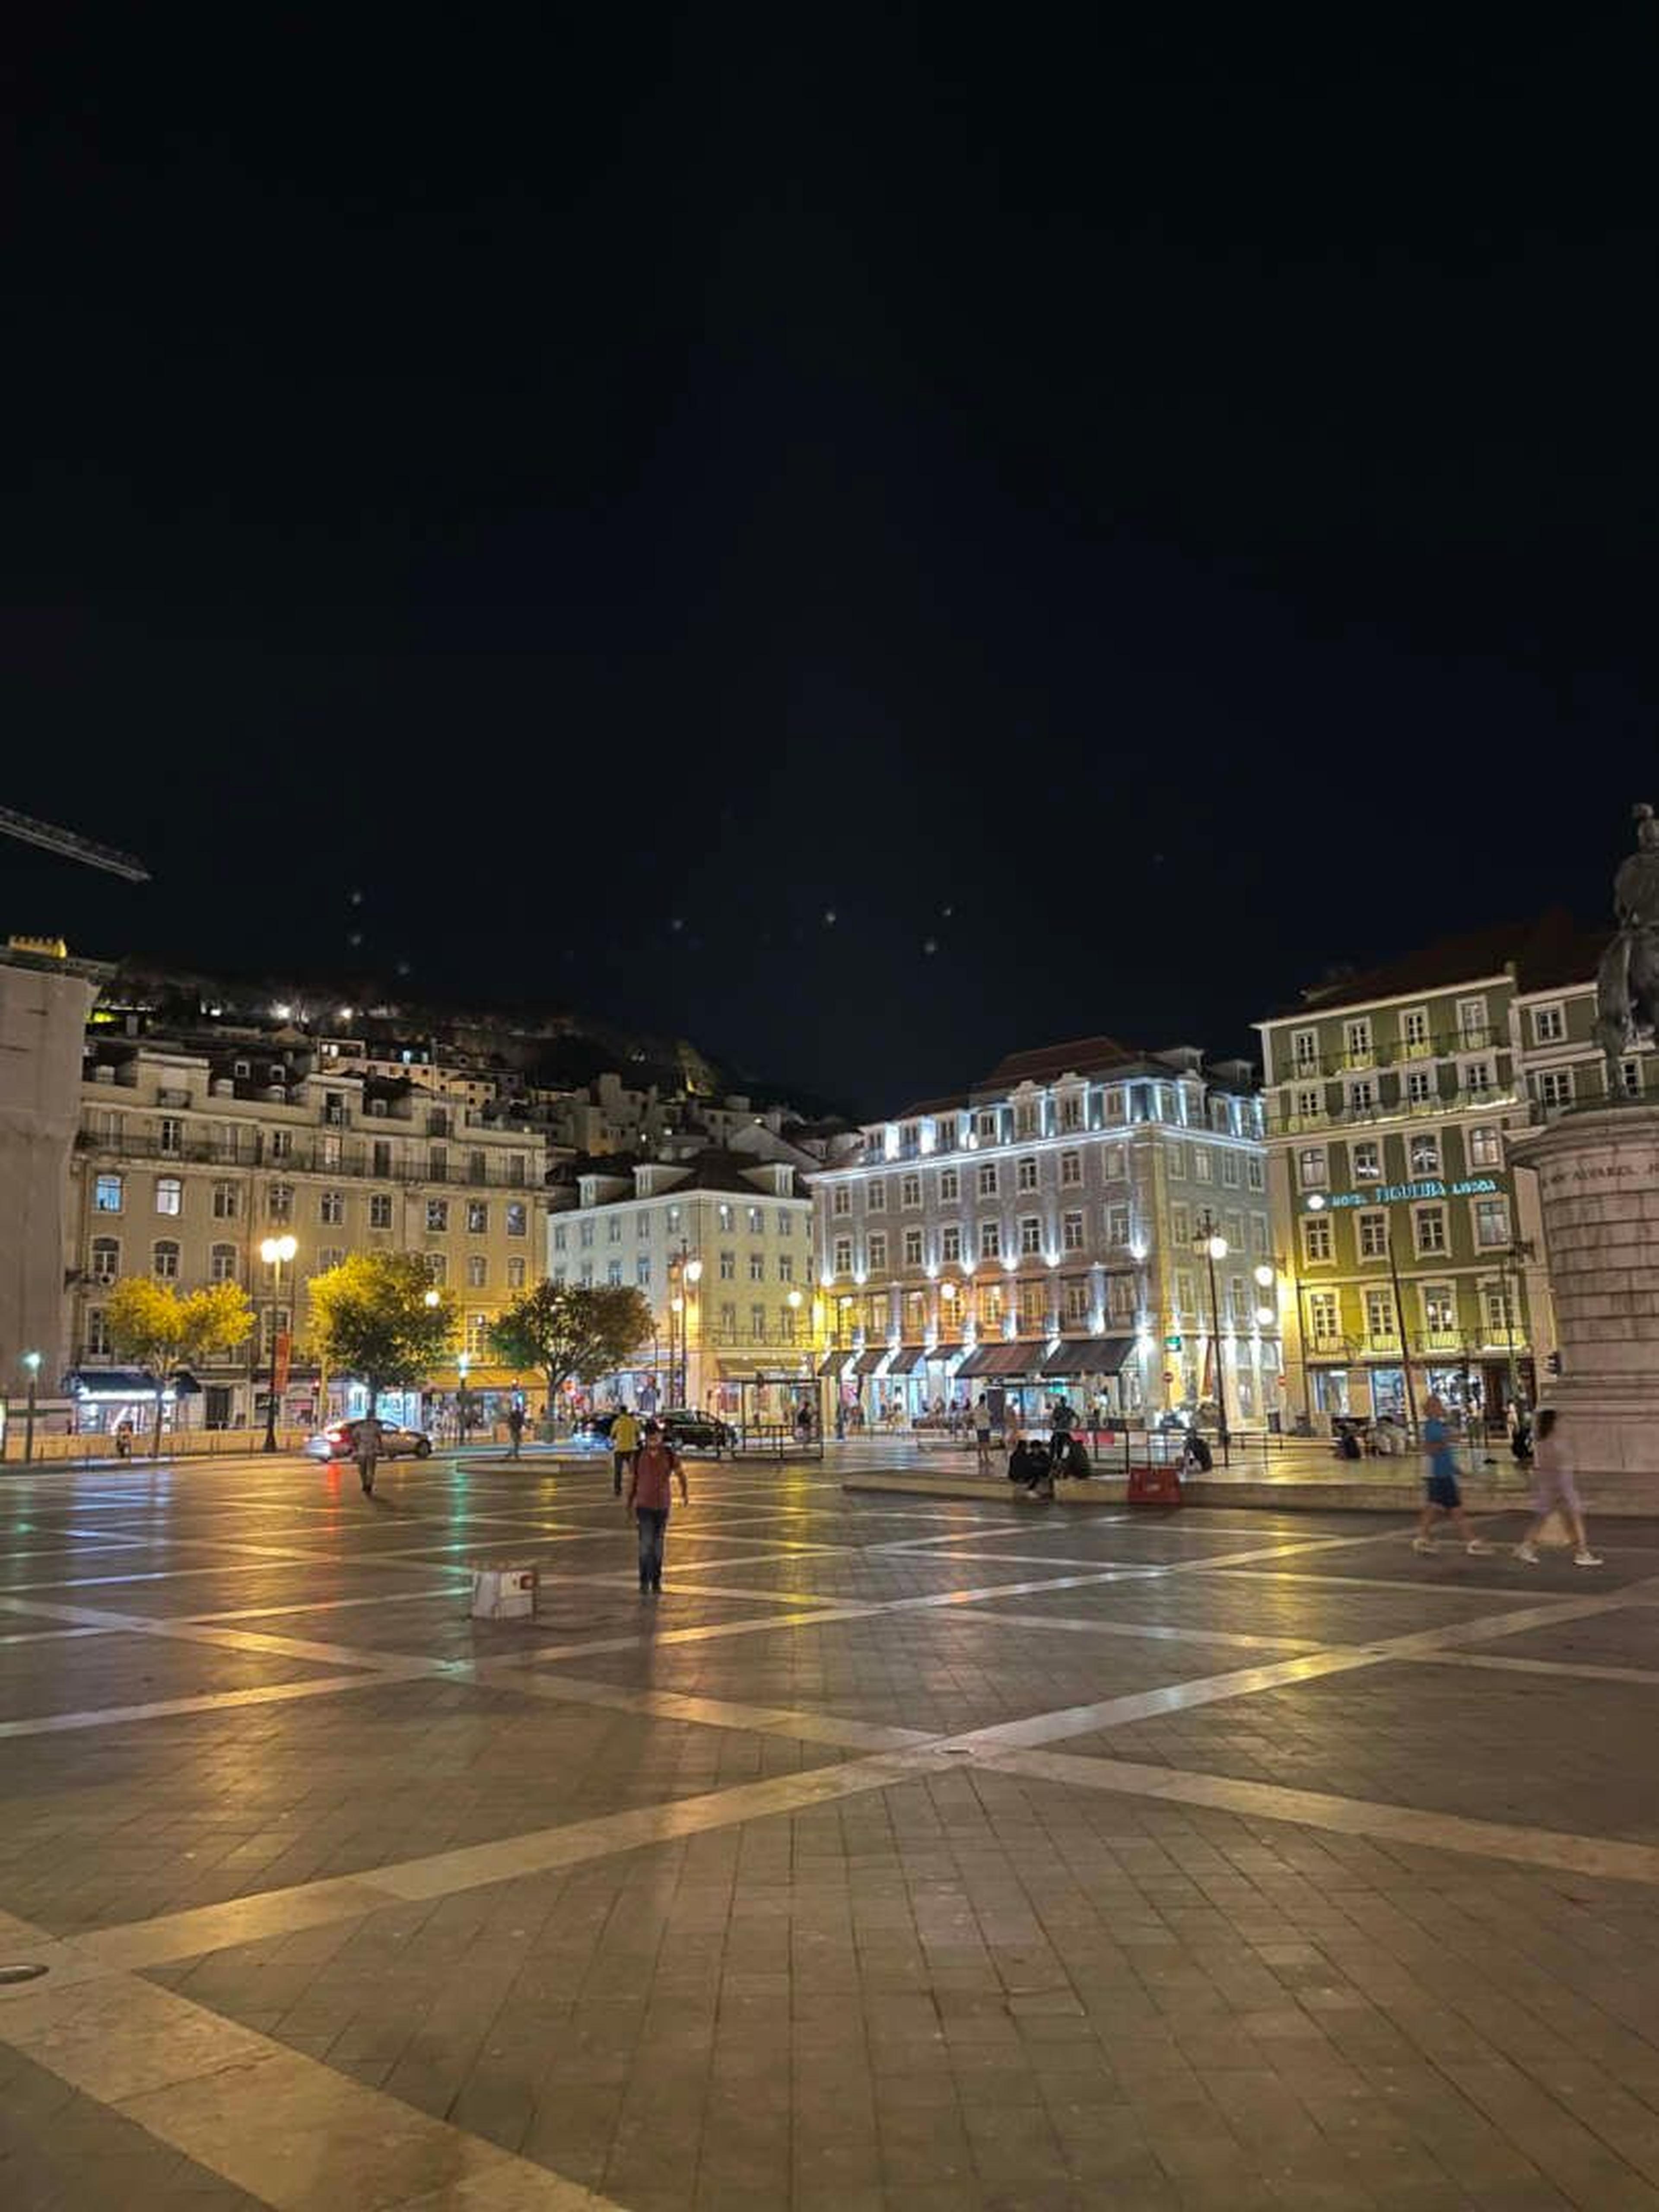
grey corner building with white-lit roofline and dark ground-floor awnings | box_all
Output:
[812,1037,1281,1427]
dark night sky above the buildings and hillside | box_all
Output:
[0,9,1659,1110]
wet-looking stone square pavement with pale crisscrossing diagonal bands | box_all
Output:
[0,1458,1659,2212]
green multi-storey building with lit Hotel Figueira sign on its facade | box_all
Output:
[1256,911,1657,1429]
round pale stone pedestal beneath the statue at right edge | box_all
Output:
[1509,1104,1659,1515]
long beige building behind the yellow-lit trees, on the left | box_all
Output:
[64,1031,547,1427]
